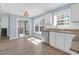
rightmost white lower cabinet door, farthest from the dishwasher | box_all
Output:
[65,34,75,53]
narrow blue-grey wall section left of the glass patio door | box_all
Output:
[10,15,17,39]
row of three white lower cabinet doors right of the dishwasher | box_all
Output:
[49,32,75,54]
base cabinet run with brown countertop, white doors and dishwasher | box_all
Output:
[42,29,79,54]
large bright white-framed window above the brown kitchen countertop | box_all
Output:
[54,9,70,25]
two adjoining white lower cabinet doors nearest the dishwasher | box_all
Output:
[49,32,65,51]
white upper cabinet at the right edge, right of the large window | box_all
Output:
[71,4,79,22]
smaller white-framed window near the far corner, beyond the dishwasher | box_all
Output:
[34,19,45,32]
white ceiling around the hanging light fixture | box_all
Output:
[0,3,67,17]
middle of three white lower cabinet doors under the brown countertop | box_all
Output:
[56,33,65,51]
